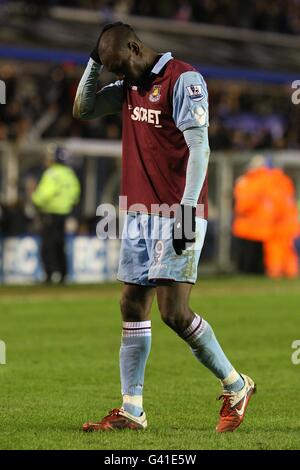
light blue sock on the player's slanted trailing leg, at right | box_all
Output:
[181,314,244,392]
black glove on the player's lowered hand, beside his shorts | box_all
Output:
[172,204,196,255]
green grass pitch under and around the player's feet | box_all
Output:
[0,278,300,450]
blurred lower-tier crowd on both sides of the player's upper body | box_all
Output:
[0,63,300,150]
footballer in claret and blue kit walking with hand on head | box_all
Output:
[73,22,255,432]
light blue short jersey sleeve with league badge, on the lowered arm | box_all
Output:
[173,71,209,132]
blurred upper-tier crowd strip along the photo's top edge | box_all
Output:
[1,0,300,34]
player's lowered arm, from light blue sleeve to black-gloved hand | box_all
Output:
[173,72,210,255]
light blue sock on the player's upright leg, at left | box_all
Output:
[120,321,151,416]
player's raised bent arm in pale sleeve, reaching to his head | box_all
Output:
[73,38,123,120]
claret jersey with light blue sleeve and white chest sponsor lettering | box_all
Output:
[103,52,208,218]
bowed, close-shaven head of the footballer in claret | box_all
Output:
[98,22,152,83]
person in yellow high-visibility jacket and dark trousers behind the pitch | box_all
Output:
[32,147,81,283]
